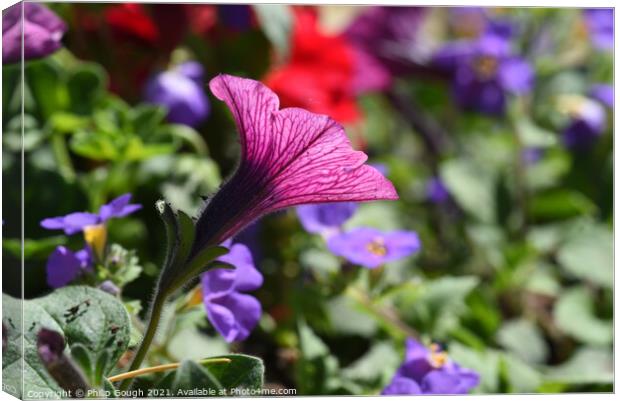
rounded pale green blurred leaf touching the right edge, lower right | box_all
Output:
[553,287,613,345]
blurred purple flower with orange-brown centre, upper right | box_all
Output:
[433,29,534,115]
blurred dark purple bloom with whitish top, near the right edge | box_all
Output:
[562,98,607,150]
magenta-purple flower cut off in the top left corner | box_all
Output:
[2,3,67,64]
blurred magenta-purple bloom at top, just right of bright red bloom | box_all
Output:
[345,6,424,93]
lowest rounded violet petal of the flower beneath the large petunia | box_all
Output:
[205,292,262,342]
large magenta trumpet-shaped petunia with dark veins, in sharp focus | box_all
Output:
[193,75,398,254]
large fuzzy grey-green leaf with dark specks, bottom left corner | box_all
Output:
[2,286,129,391]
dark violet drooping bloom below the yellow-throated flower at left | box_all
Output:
[46,246,92,288]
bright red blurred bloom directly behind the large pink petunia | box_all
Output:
[264,7,360,123]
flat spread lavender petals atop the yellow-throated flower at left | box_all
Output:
[41,194,142,235]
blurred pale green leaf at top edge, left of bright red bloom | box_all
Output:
[252,4,293,61]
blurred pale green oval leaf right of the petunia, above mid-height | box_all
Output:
[440,159,495,223]
